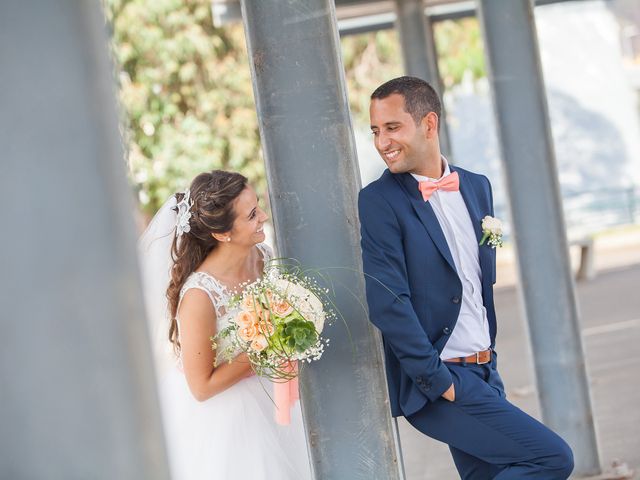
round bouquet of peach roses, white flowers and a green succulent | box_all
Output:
[212,264,335,381]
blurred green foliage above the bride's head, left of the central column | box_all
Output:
[103,0,266,215]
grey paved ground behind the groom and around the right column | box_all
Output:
[398,230,640,480]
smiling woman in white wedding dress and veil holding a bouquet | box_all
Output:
[139,170,311,480]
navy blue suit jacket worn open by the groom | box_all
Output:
[358,166,496,416]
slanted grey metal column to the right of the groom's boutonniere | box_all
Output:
[479,0,600,474]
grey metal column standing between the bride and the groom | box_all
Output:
[242,0,400,480]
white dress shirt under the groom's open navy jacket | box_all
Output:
[411,157,491,360]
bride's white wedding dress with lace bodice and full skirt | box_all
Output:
[159,244,311,480]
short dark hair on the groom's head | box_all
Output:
[371,76,442,127]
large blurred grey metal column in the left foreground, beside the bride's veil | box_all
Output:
[0,0,169,480]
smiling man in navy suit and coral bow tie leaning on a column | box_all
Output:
[358,77,573,480]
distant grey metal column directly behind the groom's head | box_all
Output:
[395,0,452,156]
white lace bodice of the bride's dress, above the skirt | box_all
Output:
[177,243,273,348]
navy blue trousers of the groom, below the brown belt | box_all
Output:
[407,353,573,480]
